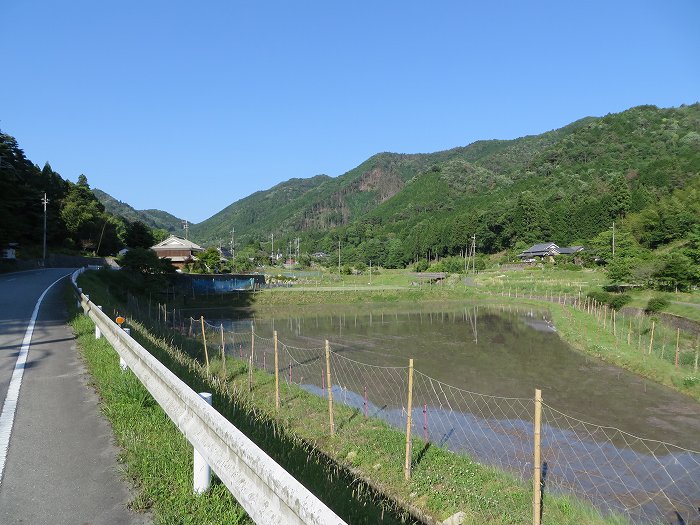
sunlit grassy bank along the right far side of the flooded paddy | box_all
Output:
[464,268,700,401]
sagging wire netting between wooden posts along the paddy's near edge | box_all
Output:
[123,292,700,524]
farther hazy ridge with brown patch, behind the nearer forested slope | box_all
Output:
[191,114,588,244]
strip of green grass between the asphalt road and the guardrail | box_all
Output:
[70,315,252,525]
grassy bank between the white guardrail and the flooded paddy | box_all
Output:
[82,274,624,524]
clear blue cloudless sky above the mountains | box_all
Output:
[0,0,700,222]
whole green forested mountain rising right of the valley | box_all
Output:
[192,104,700,266]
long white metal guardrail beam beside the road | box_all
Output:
[71,269,345,525]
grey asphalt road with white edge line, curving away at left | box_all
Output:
[0,269,150,525]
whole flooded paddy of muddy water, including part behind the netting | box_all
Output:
[229,303,700,523]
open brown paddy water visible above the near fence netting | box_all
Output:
[245,304,700,450]
